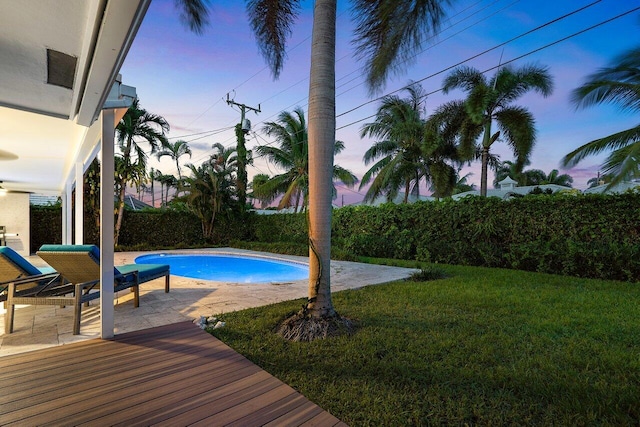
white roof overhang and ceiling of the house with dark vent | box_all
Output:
[0,0,151,194]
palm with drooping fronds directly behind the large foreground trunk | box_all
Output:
[256,107,358,212]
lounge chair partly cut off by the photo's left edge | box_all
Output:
[0,246,60,307]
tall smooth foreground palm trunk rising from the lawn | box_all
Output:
[307,0,337,318]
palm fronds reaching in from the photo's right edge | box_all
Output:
[562,46,640,187]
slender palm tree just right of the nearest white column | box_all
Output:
[114,98,169,246]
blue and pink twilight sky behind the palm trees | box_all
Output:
[121,0,640,204]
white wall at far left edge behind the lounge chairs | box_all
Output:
[0,193,31,256]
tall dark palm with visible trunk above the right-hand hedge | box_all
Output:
[443,65,553,196]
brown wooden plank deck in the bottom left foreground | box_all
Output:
[0,322,346,427]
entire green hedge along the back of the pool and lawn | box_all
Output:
[32,193,640,281]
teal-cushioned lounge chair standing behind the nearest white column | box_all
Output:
[5,245,169,335]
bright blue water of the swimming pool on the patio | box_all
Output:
[135,254,309,283]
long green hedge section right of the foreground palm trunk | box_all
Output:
[333,194,640,281]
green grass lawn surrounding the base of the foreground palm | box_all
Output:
[208,261,640,426]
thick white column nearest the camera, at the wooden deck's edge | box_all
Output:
[100,110,115,339]
